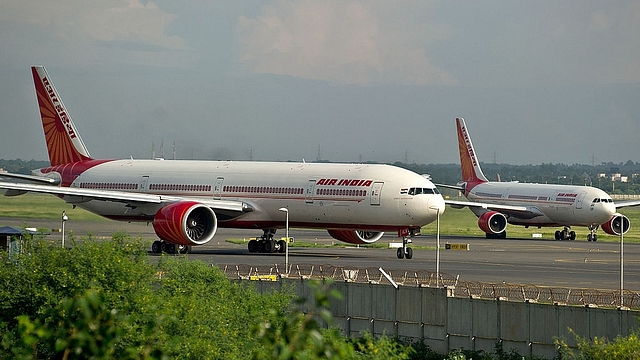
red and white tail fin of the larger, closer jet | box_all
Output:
[31,66,91,166]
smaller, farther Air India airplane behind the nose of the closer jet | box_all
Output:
[439,118,640,241]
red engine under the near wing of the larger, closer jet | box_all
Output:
[153,201,218,246]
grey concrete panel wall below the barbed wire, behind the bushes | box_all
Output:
[248,278,640,358]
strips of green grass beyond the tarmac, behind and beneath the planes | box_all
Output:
[0,194,640,242]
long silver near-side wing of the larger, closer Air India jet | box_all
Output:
[0,182,253,214]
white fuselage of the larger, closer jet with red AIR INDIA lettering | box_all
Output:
[36,160,444,231]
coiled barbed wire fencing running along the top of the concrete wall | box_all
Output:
[222,264,640,310]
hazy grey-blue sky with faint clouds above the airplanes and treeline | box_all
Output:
[0,0,640,165]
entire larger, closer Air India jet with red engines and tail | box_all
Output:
[0,66,445,259]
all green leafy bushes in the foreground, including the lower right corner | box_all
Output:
[0,233,640,360]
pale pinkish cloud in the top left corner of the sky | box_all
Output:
[0,0,188,67]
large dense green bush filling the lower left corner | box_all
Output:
[0,234,291,359]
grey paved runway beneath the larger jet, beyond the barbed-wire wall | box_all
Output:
[0,218,640,291]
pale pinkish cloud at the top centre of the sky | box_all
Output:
[237,0,457,85]
